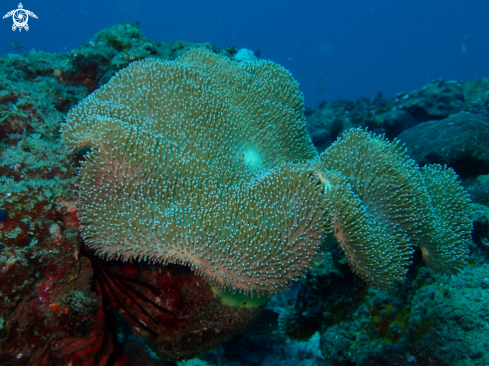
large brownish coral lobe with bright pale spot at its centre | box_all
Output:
[62,49,326,294]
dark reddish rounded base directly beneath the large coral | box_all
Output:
[85,250,261,360]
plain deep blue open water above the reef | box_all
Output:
[0,0,489,107]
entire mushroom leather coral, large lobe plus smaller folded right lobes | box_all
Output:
[62,49,470,295]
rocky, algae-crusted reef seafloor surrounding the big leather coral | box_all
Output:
[0,24,489,366]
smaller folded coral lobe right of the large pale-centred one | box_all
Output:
[319,129,472,288]
